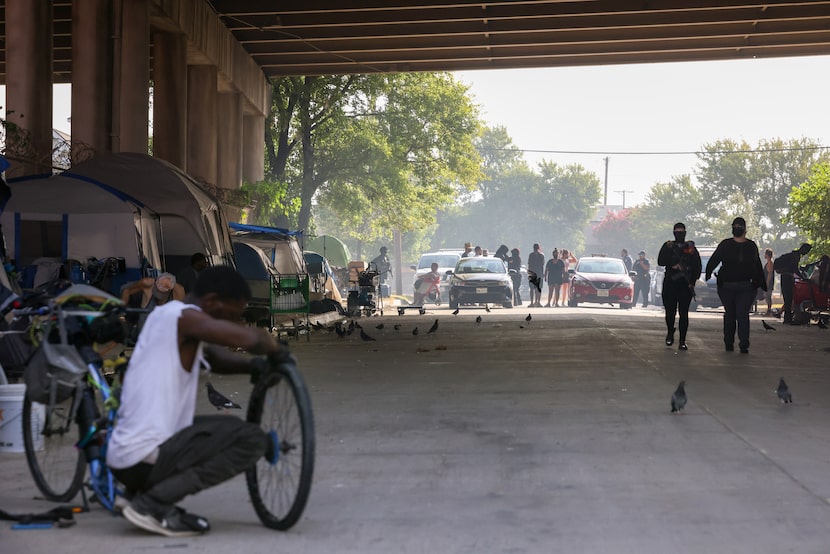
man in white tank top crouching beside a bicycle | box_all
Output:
[107,266,288,537]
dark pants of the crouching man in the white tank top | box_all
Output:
[113,415,268,505]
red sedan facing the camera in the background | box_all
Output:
[568,256,636,309]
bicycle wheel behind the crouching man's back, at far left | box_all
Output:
[23,388,85,502]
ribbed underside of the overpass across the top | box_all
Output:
[208,0,830,76]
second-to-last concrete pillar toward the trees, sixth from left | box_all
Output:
[216,91,242,190]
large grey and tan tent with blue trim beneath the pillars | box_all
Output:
[0,153,233,288]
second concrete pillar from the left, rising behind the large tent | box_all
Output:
[72,0,112,163]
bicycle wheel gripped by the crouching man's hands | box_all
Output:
[245,365,314,531]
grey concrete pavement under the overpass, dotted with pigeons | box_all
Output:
[0,305,830,554]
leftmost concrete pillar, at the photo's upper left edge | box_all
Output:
[5,0,52,177]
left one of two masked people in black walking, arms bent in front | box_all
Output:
[657,223,701,350]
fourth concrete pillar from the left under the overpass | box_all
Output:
[153,33,187,171]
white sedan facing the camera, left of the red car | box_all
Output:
[448,257,513,309]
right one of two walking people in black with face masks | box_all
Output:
[706,217,767,354]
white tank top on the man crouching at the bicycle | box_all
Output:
[107,300,207,469]
